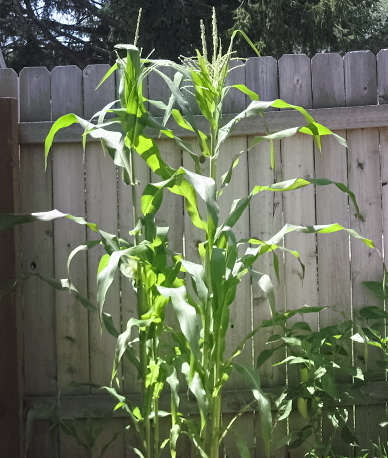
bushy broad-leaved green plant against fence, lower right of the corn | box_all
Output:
[257,310,364,456]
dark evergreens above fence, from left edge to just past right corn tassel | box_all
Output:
[0,0,239,70]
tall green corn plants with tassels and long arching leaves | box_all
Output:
[0,9,373,458]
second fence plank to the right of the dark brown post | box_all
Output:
[51,66,89,456]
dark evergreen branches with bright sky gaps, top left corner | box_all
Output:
[0,0,116,70]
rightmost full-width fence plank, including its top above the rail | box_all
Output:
[344,51,385,447]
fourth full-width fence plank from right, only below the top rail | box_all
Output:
[248,142,287,458]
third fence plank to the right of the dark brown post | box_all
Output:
[83,65,125,453]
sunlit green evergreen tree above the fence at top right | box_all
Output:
[235,0,388,58]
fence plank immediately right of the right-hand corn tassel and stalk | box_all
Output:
[217,60,255,458]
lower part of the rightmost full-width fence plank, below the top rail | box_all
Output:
[348,129,385,446]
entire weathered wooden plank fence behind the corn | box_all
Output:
[0,50,388,458]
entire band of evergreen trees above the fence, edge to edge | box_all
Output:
[0,0,388,71]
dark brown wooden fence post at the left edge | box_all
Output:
[0,98,22,457]
